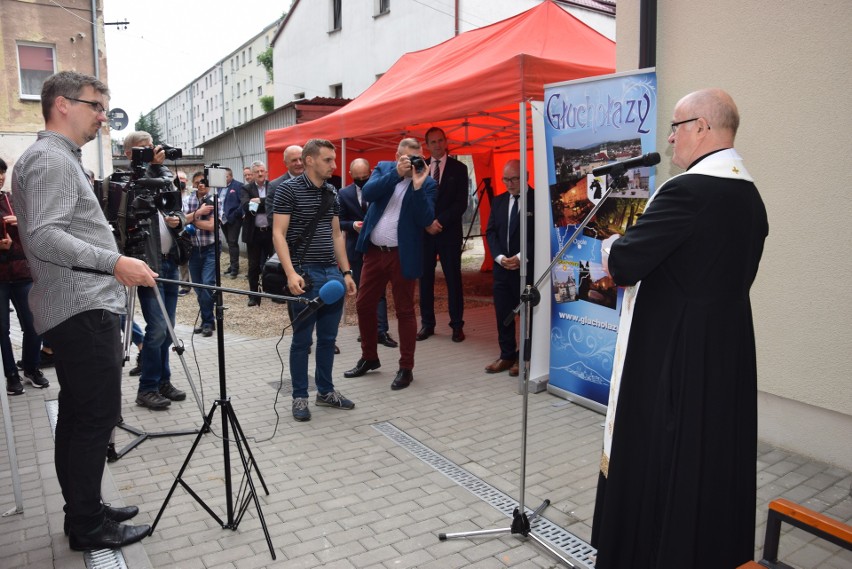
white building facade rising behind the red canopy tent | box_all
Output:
[273,0,615,103]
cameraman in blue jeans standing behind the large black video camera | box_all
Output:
[124,131,186,411]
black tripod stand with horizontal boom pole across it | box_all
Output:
[151,188,309,559]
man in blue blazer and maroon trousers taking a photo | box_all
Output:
[343,138,436,390]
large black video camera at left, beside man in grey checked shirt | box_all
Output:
[105,145,183,261]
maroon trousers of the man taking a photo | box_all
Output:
[355,245,417,369]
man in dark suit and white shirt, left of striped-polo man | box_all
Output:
[240,160,275,306]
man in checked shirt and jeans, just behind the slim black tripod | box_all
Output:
[183,171,217,338]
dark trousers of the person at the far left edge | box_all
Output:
[0,281,41,377]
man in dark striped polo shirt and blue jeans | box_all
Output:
[272,139,357,421]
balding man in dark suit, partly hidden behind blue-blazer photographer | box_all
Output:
[337,158,399,348]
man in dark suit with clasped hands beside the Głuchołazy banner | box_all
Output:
[485,160,534,376]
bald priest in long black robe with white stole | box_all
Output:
[592,89,768,569]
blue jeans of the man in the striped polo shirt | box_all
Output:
[290,265,343,399]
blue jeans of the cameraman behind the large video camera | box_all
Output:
[136,257,178,393]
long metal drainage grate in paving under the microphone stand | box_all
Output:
[373,422,597,568]
